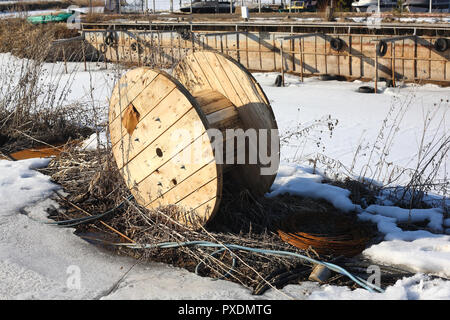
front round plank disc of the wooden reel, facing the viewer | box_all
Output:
[109,68,222,227]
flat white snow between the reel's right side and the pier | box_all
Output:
[254,73,450,188]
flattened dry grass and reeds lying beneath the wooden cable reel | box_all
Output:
[37,145,394,294]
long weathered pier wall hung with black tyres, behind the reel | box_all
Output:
[82,19,450,86]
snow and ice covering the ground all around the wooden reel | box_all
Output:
[0,55,450,299]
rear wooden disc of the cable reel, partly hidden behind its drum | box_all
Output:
[173,51,280,195]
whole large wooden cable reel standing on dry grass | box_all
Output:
[109,51,279,229]
